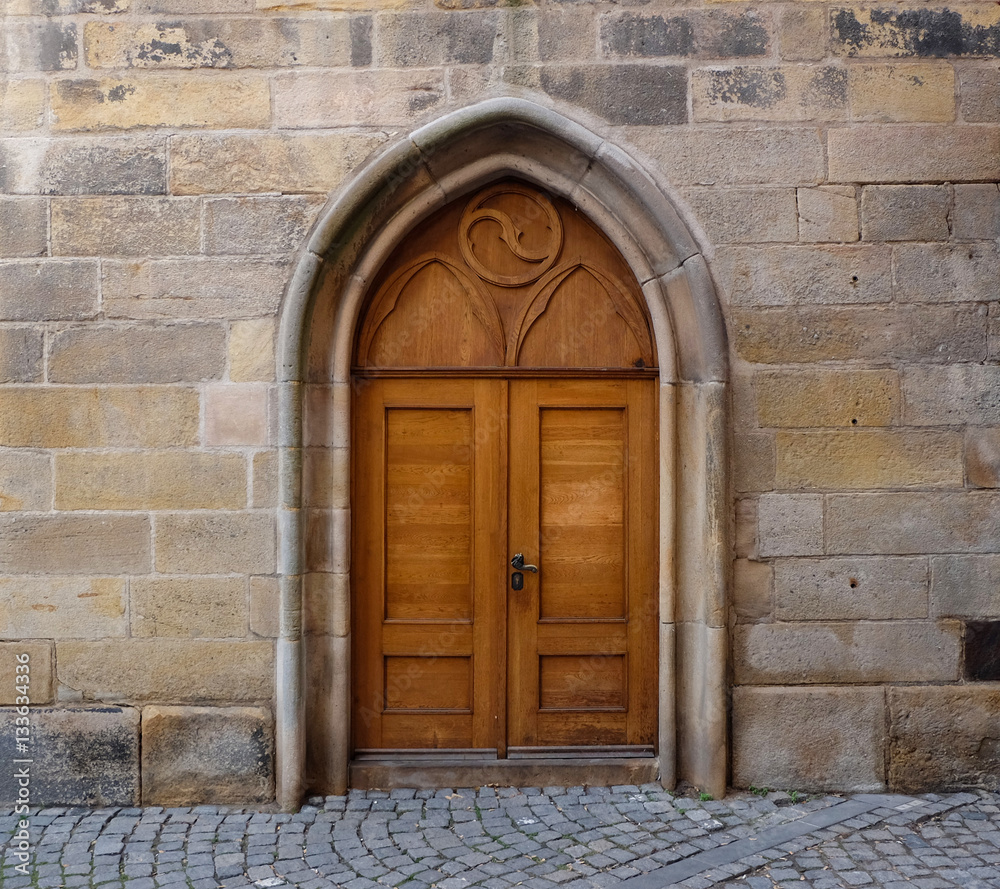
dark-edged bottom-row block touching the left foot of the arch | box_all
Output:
[142,707,274,806]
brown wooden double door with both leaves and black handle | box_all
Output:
[351,372,658,758]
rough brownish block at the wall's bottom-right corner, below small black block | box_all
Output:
[888,684,1000,793]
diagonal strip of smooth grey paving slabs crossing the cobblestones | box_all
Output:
[620,793,978,889]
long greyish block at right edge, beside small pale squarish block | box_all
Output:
[826,491,1000,555]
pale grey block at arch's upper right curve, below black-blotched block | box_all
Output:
[626,127,826,186]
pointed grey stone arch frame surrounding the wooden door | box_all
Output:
[275,98,729,810]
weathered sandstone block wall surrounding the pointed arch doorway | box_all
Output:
[0,0,1000,804]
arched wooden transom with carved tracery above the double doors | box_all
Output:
[357,182,656,368]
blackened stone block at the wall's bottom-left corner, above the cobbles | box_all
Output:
[0,707,139,806]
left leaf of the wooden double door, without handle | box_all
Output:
[351,378,507,751]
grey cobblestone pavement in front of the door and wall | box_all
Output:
[0,784,1000,889]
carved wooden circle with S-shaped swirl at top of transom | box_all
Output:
[458,183,563,287]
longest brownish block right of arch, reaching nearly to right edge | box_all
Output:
[730,305,987,364]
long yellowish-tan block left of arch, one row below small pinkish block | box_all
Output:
[56,451,247,510]
